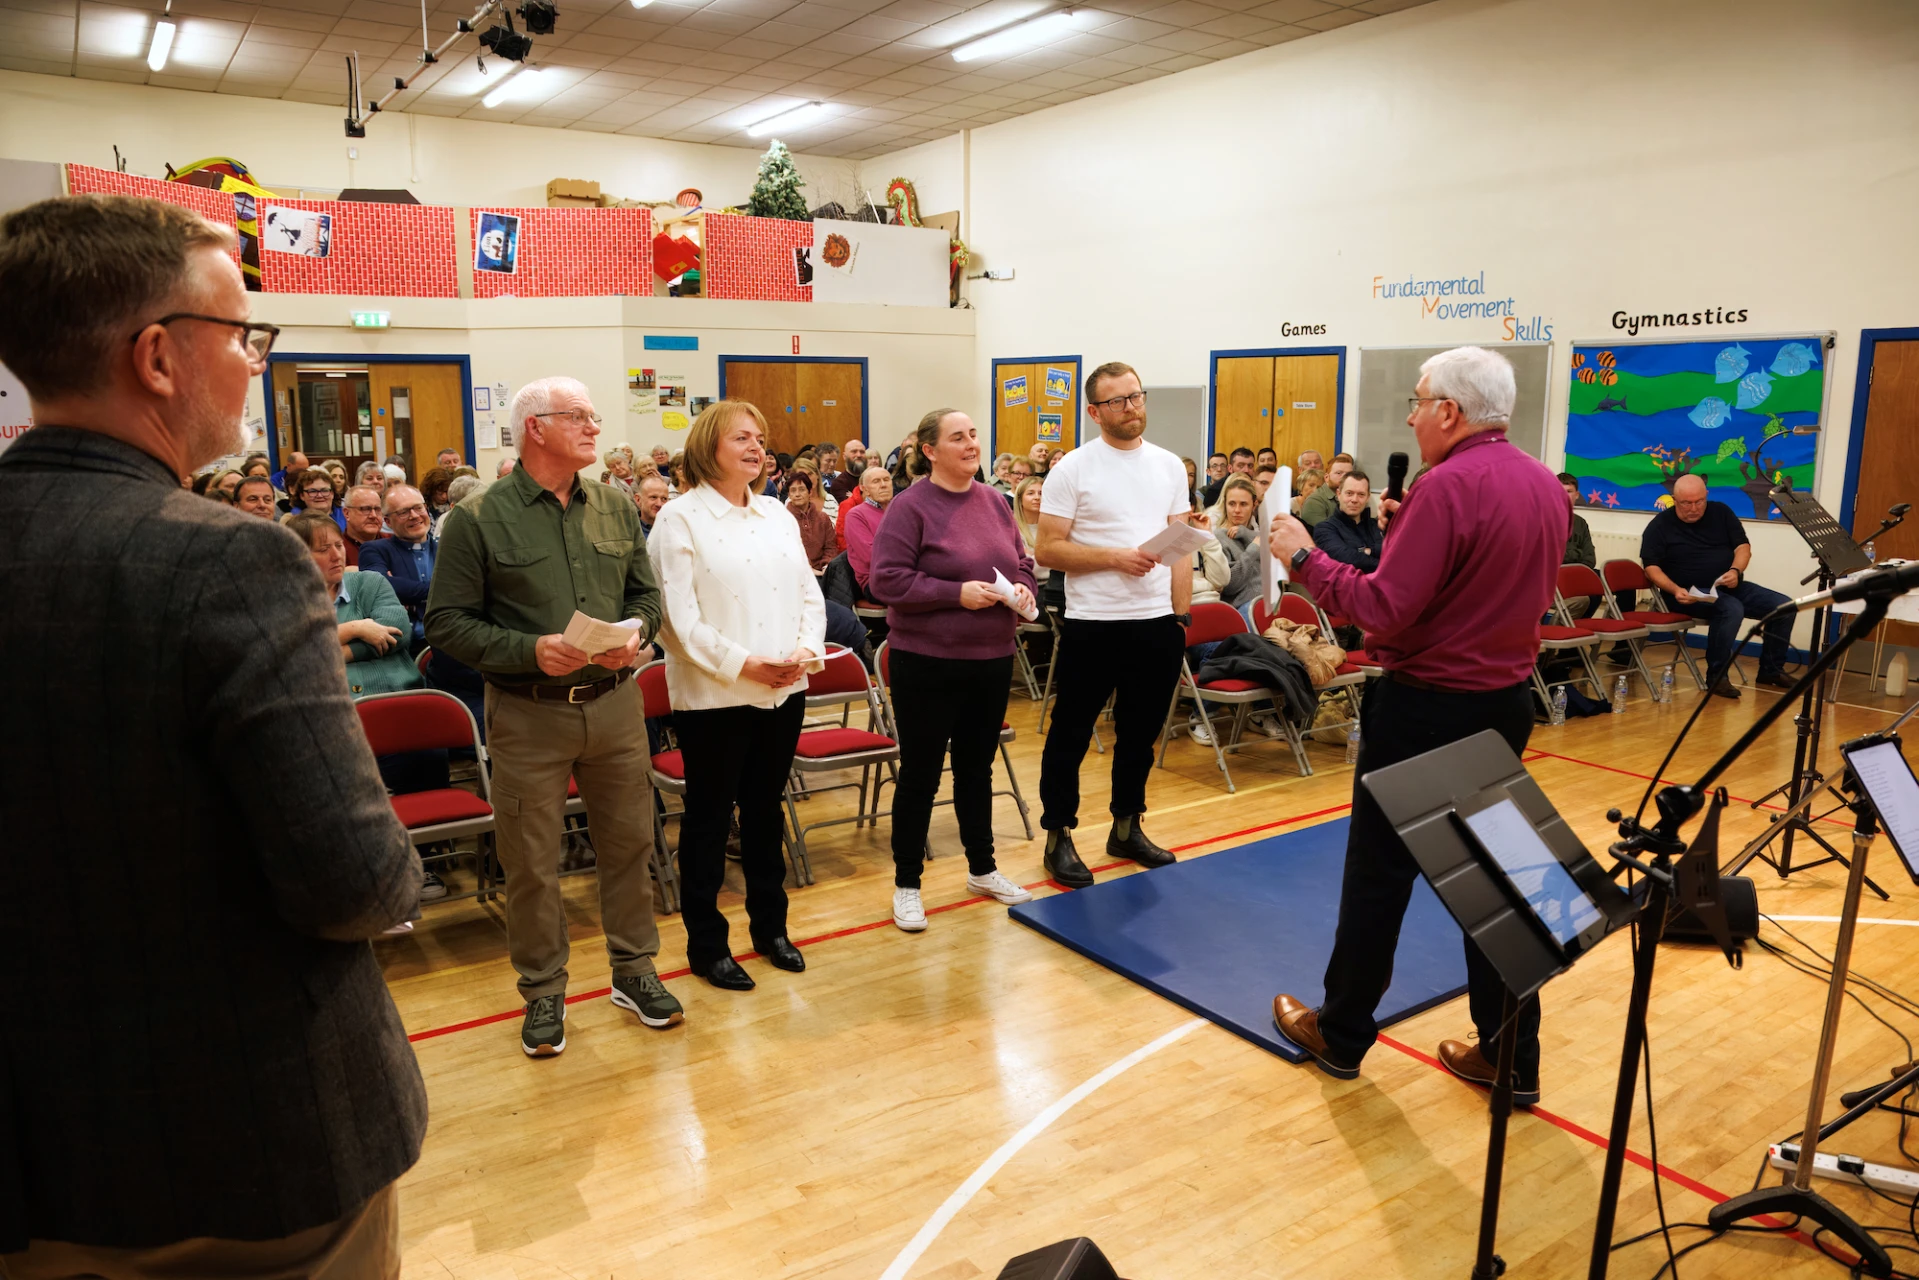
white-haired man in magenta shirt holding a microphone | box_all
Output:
[1272,347,1572,1105]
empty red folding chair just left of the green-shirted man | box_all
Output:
[353,689,493,898]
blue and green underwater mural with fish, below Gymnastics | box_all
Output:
[1566,334,1827,520]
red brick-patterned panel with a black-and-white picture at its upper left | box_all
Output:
[259,200,461,297]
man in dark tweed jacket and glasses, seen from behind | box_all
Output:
[0,196,426,1278]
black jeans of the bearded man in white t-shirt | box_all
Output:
[1040,614,1186,831]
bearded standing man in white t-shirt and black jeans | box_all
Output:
[1036,363,1194,889]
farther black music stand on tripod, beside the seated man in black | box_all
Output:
[1725,486,1886,898]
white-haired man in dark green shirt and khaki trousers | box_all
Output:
[426,378,685,1057]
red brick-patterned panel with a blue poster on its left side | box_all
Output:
[468,209,652,297]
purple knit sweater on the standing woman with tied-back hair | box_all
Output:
[869,480,1038,658]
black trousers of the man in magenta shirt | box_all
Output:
[1318,677,1539,1088]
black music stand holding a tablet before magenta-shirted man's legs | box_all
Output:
[1359,729,1639,1280]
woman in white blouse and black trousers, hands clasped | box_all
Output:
[647,399,827,990]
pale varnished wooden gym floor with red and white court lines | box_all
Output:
[378,677,1919,1280]
